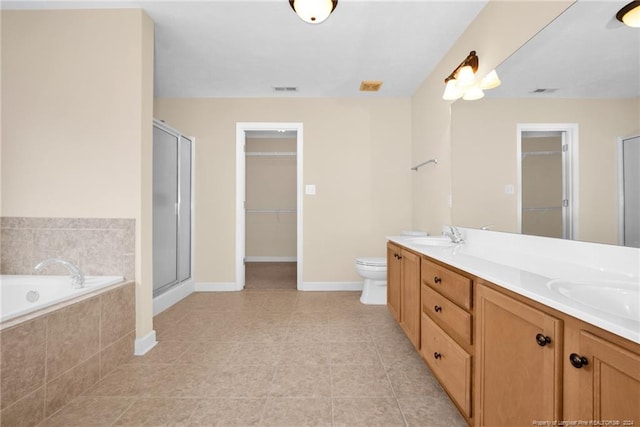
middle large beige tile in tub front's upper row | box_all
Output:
[47,298,100,381]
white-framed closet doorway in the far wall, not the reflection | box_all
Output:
[235,123,303,290]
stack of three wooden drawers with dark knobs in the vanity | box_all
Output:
[420,257,474,422]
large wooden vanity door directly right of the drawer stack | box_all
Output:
[475,284,562,427]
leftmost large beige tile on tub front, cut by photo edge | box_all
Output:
[0,319,46,408]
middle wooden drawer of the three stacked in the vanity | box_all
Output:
[422,284,471,344]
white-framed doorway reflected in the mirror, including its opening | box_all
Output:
[517,123,578,239]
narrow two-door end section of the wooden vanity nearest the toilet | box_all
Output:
[387,243,420,349]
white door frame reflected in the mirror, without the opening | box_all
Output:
[516,123,579,240]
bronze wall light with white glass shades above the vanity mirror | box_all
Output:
[442,50,500,101]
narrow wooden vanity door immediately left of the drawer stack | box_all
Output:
[400,250,422,350]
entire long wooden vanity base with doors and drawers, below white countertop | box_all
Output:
[387,242,640,427]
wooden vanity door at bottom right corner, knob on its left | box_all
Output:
[566,331,640,426]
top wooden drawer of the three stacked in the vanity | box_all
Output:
[422,258,471,309]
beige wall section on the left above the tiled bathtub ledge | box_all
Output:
[2,9,153,342]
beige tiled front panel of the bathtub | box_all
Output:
[0,281,135,427]
